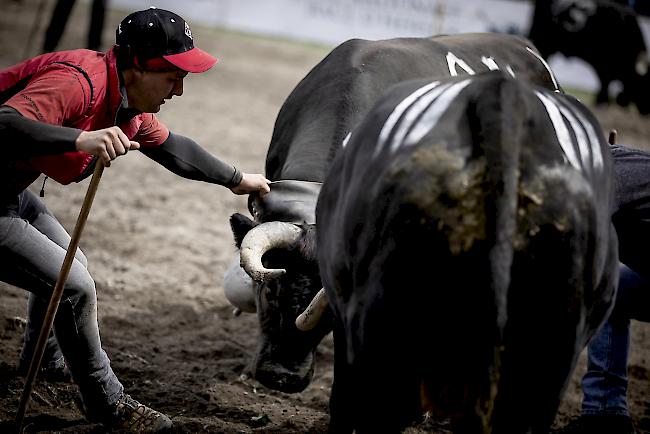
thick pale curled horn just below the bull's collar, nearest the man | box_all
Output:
[239,222,302,282]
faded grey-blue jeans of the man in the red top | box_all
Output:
[0,190,123,422]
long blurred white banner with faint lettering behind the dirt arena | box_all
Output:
[111,0,531,45]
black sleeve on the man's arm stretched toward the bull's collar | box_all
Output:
[140,133,242,188]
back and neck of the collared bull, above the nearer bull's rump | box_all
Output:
[266,33,558,182]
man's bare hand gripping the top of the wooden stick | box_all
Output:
[75,127,140,167]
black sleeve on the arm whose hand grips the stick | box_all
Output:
[0,106,81,158]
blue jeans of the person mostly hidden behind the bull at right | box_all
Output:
[582,265,650,416]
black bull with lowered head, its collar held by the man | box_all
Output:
[225,33,558,392]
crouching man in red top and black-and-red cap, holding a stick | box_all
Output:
[0,8,269,433]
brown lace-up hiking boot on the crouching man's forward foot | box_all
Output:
[110,393,173,434]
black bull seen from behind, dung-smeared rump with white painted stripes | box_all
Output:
[316,71,618,434]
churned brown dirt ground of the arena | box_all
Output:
[0,0,650,433]
